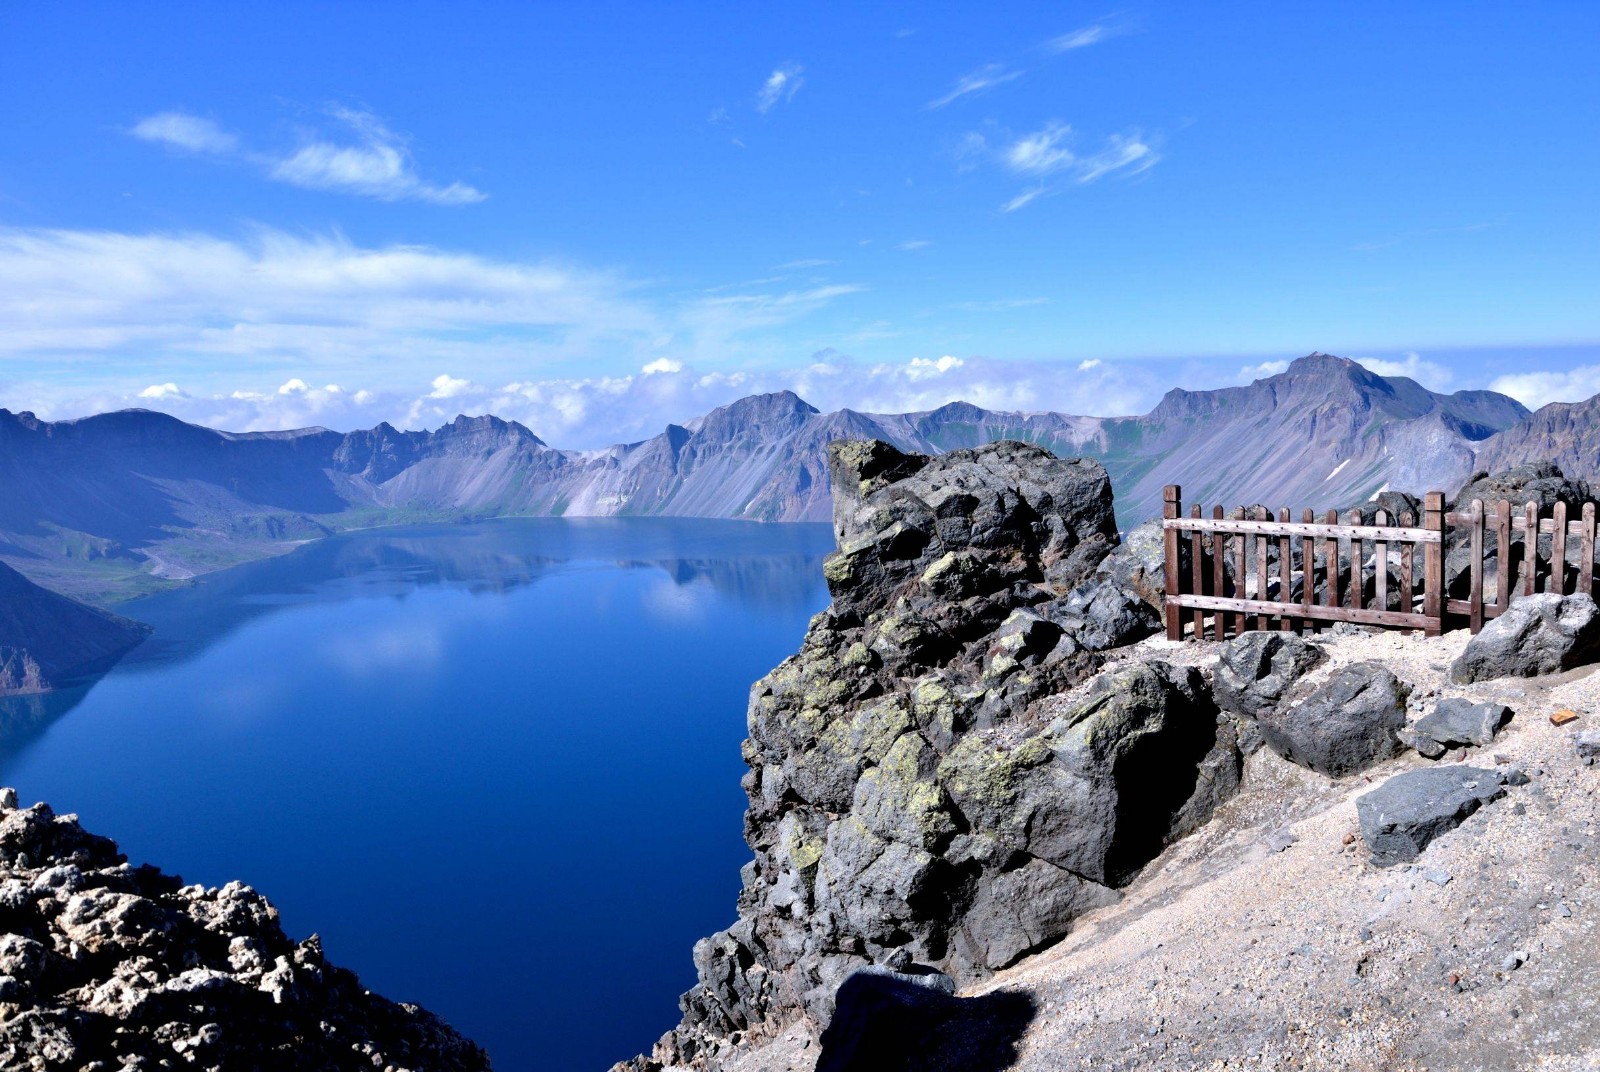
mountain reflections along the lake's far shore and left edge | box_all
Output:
[0,518,834,758]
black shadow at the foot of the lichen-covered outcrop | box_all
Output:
[816,968,1038,1072]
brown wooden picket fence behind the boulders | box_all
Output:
[1162,485,1595,640]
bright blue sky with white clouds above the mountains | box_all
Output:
[0,0,1600,448]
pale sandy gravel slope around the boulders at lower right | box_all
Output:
[707,632,1600,1072]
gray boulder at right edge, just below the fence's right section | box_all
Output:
[1450,592,1600,685]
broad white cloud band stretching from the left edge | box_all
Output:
[0,229,662,371]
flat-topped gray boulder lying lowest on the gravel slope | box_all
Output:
[1355,766,1506,867]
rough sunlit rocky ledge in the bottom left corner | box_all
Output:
[0,789,490,1072]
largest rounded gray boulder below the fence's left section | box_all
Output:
[1258,662,1410,778]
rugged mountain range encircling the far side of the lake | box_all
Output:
[0,354,1600,602]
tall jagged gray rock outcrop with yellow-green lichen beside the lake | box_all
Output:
[634,442,1242,1067]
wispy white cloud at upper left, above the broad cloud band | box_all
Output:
[130,106,488,205]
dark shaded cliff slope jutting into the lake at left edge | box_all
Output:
[0,563,150,696]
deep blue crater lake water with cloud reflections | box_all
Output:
[0,518,832,1072]
